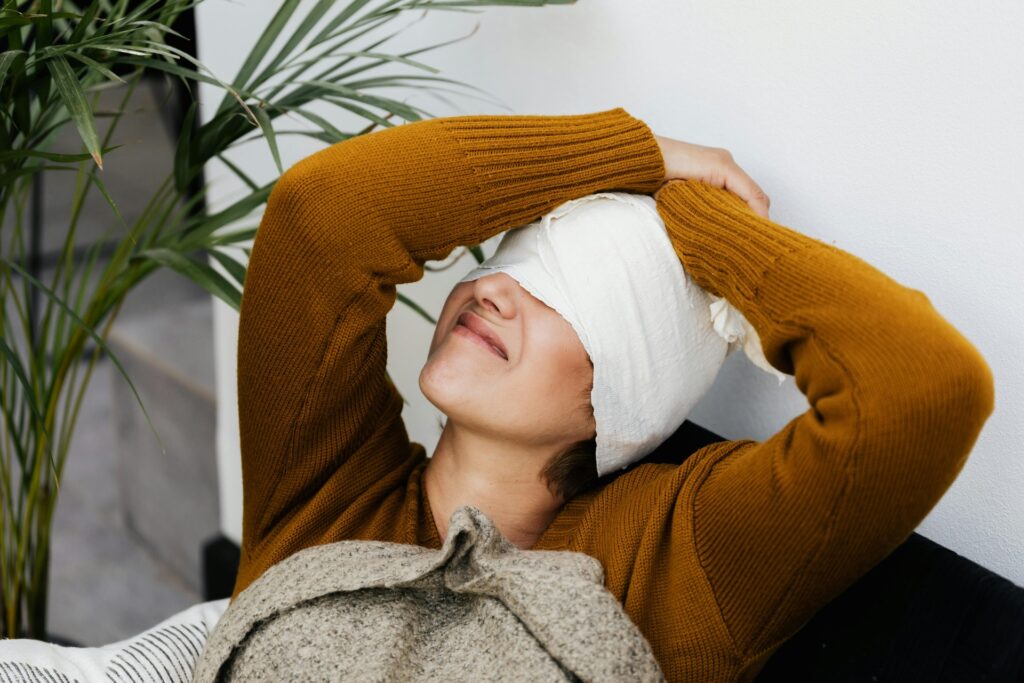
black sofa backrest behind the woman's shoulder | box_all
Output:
[638,420,1024,683]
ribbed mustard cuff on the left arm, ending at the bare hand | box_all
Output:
[437,106,666,240]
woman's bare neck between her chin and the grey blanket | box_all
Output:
[423,420,562,549]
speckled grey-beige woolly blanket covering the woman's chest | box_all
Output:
[194,506,665,683]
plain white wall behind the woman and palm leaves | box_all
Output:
[193,0,1024,585]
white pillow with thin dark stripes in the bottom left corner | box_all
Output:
[0,598,229,683]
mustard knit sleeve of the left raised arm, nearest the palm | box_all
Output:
[234,108,665,595]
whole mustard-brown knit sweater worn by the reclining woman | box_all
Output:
[234,108,994,681]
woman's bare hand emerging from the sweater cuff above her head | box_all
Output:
[654,135,771,218]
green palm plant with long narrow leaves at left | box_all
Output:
[0,0,574,639]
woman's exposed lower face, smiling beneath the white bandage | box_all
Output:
[420,271,596,450]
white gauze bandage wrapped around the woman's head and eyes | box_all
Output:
[460,191,786,475]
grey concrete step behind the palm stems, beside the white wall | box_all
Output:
[108,296,220,592]
